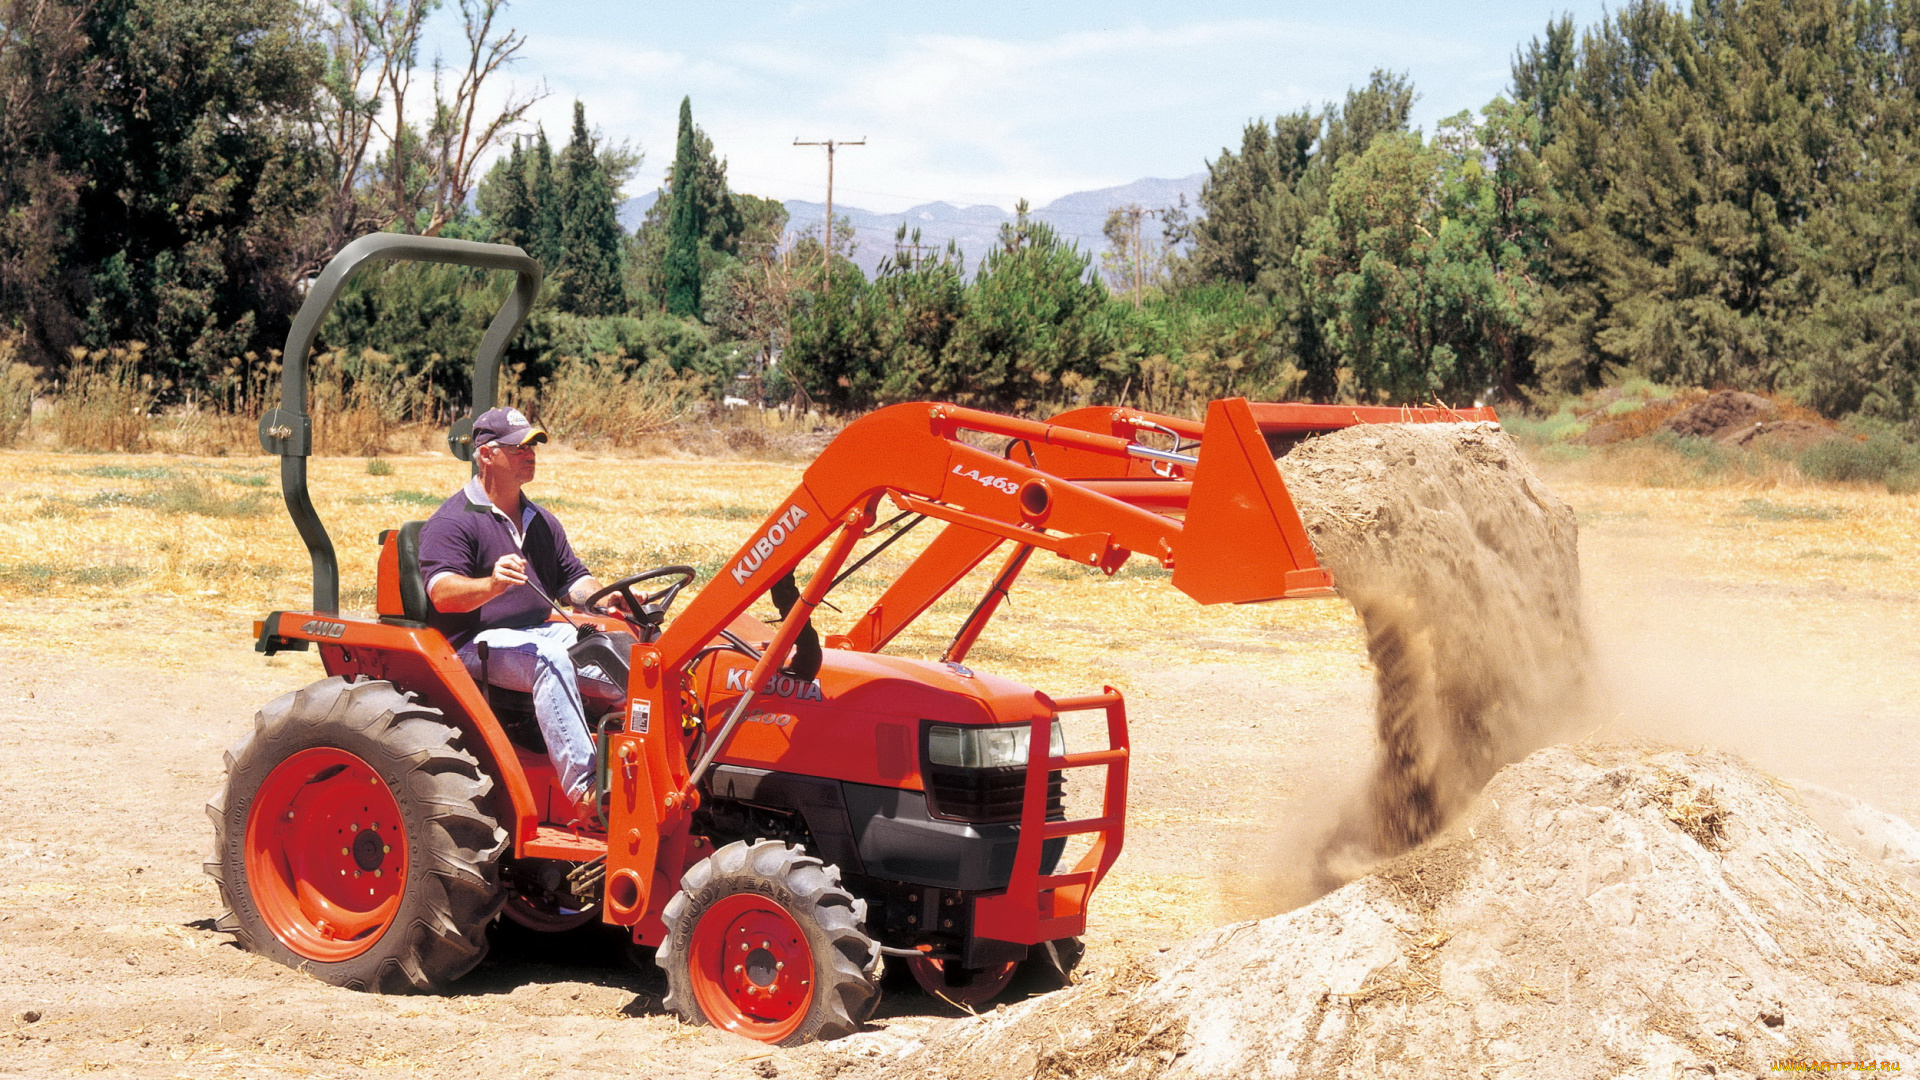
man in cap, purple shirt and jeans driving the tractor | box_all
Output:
[420,407,626,819]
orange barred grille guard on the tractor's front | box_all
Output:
[973,686,1129,945]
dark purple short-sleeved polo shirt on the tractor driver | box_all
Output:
[420,477,588,650]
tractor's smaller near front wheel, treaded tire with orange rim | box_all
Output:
[653,840,879,1045]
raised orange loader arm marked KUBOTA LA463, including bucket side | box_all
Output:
[657,400,1332,669]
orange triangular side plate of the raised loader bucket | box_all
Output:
[1173,398,1334,603]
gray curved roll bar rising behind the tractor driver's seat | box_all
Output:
[259,233,543,615]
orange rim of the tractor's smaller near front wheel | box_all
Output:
[687,894,814,1042]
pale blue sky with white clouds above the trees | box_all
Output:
[436,0,1605,211]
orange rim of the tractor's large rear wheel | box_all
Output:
[246,746,407,963]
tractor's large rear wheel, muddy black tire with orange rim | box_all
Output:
[205,678,507,994]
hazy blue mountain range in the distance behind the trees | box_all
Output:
[620,173,1206,277]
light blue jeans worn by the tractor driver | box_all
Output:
[461,623,593,801]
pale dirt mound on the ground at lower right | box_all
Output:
[864,746,1920,1080]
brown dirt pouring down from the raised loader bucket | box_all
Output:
[1281,423,1588,883]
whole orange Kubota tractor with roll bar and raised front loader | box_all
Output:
[207,234,1492,1043]
